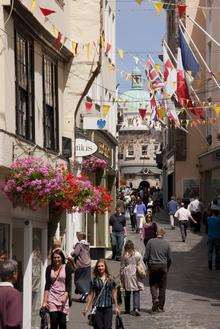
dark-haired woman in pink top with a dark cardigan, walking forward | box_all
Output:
[42,249,72,329]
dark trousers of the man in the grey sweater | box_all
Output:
[149,264,167,309]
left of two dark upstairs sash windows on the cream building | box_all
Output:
[15,31,34,142]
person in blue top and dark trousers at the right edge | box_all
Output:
[207,204,220,271]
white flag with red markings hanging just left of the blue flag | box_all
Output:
[163,44,177,97]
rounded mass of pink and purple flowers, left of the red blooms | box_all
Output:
[3,157,63,210]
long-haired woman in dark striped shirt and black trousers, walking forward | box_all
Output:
[83,259,120,329]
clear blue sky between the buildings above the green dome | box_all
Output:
[116,0,166,92]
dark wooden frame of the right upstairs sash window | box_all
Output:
[42,51,59,152]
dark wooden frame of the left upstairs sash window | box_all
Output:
[14,24,35,143]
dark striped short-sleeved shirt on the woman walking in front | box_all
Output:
[90,277,116,308]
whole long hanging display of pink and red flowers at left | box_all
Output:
[3,157,112,213]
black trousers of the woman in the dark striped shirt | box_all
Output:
[94,307,113,329]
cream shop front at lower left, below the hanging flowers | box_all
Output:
[0,193,48,329]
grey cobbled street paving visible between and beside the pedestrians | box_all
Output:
[69,213,220,329]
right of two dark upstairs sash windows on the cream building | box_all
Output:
[43,56,59,151]
